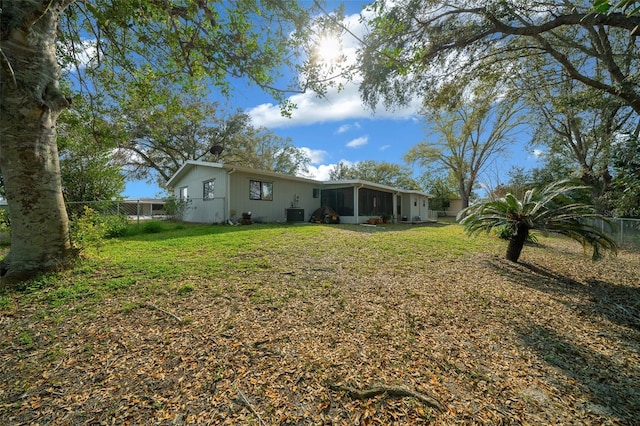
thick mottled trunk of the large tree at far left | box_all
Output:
[0,0,74,286]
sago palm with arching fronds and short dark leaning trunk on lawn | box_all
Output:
[458,181,617,262]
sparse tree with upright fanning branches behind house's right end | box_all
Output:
[405,85,521,207]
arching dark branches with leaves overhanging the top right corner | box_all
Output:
[359,0,640,113]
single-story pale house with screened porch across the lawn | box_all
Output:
[167,161,433,224]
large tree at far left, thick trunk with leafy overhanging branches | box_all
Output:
[0,0,316,285]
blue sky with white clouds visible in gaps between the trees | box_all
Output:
[123,1,539,198]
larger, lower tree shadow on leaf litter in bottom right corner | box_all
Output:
[516,323,640,425]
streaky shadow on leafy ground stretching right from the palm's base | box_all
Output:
[489,258,640,332]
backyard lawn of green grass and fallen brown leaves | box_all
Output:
[0,223,640,425]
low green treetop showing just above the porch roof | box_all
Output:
[329,160,420,189]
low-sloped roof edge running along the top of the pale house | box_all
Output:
[167,160,431,197]
